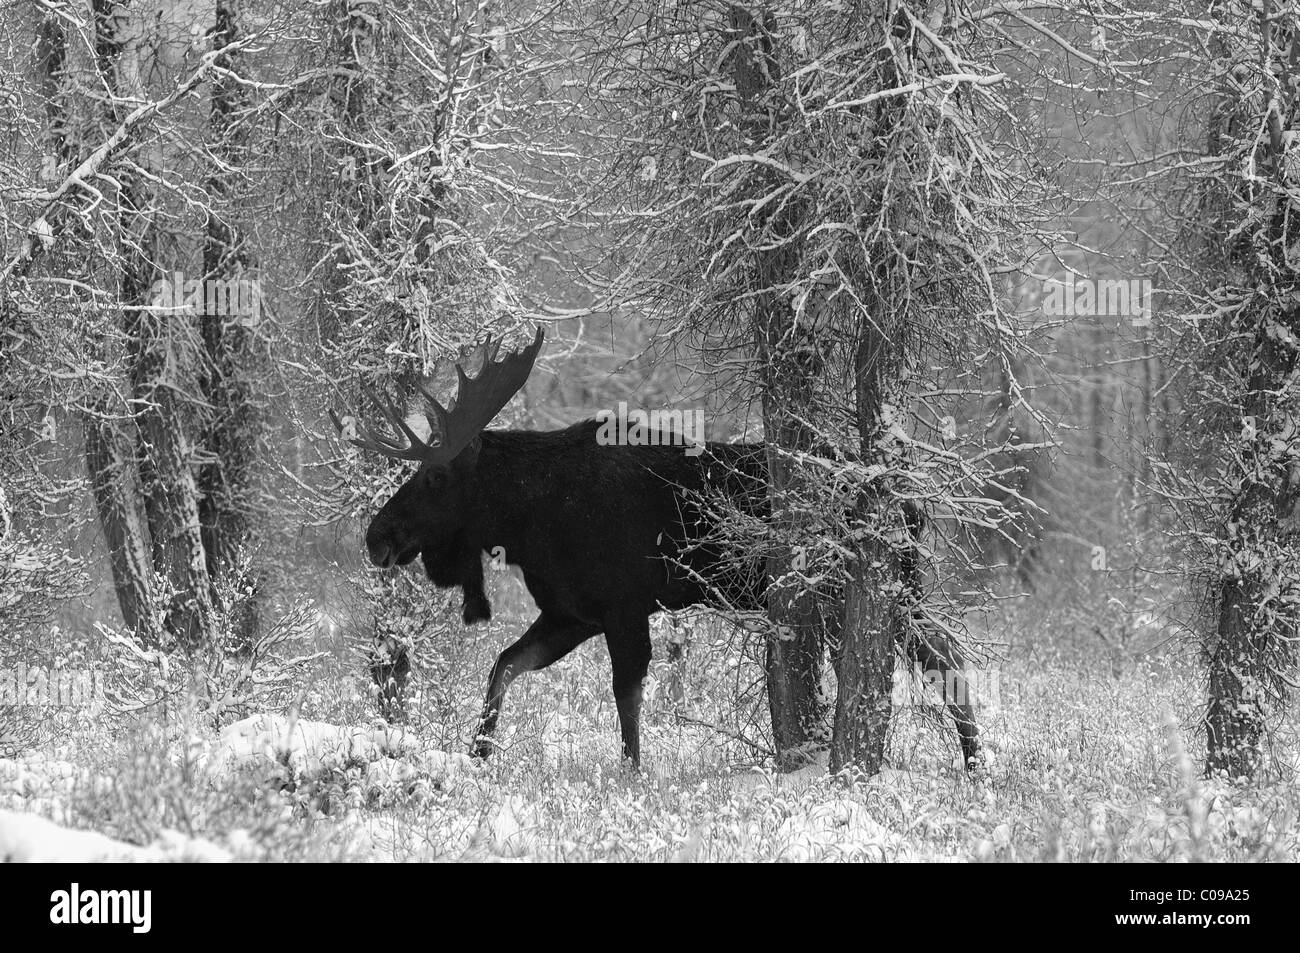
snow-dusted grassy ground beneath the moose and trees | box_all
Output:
[0,616,1300,861]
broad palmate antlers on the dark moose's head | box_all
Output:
[329,328,546,463]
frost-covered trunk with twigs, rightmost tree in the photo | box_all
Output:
[1201,3,1300,777]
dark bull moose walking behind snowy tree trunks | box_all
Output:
[330,330,978,764]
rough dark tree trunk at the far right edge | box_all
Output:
[1204,13,1300,777]
